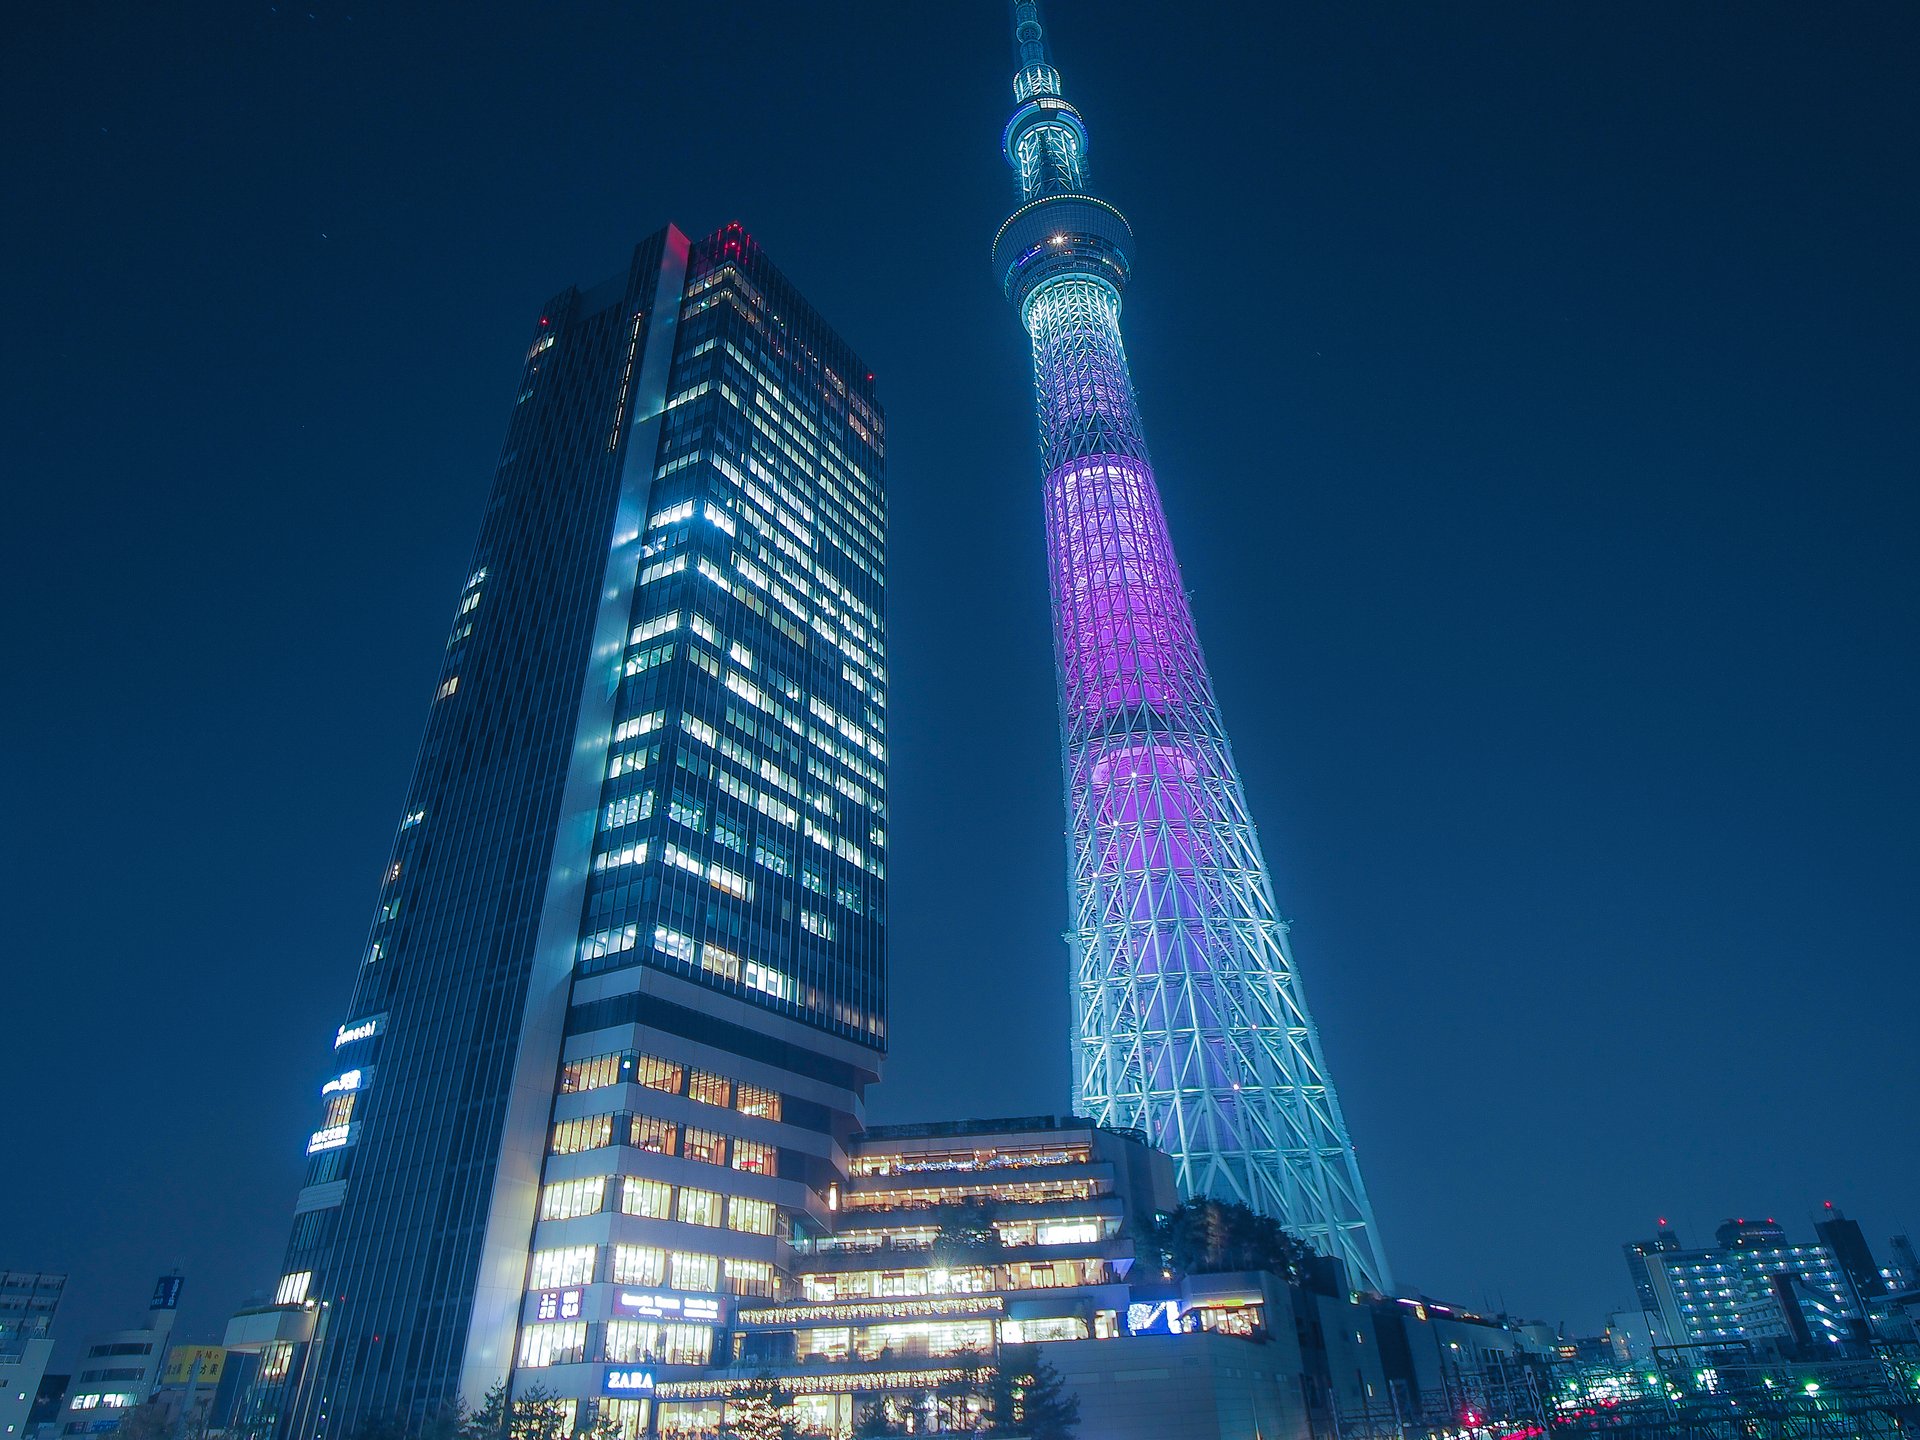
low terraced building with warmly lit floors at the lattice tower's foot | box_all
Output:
[618,1117,1555,1440]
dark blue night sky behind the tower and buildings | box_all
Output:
[0,0,1920,1359]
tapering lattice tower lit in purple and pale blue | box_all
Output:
[993,2,1390,1290]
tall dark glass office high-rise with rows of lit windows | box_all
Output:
[243,225,887,1440]
